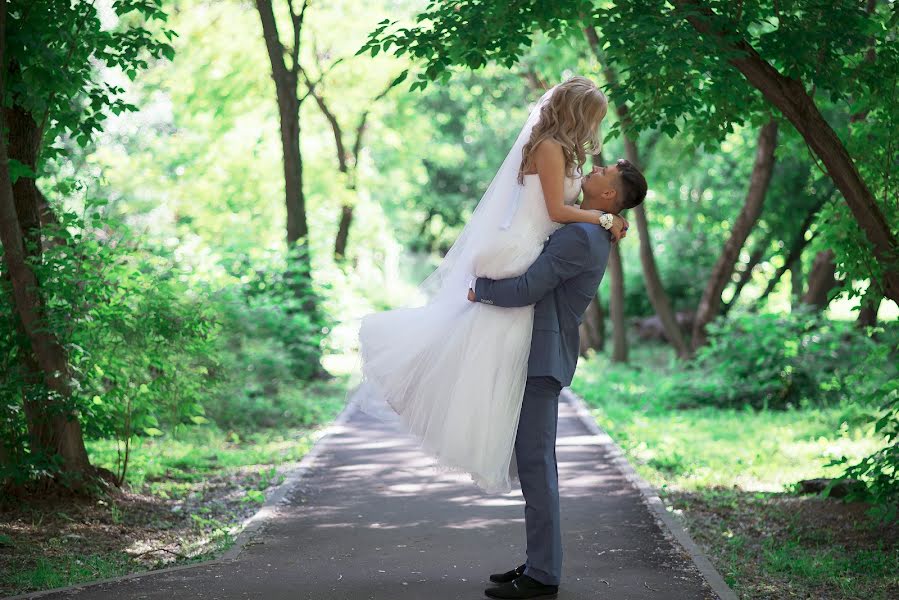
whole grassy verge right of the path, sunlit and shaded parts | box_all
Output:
[572,346,899,600]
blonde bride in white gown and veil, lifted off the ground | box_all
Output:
[351,77,621,493]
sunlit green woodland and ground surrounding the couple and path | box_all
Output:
[0,0,899,598]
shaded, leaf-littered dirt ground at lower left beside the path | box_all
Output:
[0,469,280,596]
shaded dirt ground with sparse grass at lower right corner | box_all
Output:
[665,490,899,600]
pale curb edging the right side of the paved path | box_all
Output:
[561,387,739,600]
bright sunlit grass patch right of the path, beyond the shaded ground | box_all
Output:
[572,346,883,491]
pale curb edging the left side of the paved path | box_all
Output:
[0,397,359,600]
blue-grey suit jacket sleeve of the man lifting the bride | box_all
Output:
[474,227,593,308]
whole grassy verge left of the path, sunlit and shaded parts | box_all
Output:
[0,379,346,596]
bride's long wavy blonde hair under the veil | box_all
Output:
[518,76,609,183]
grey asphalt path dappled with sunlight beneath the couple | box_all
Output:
[21,395,733,600]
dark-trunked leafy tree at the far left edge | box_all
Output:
[0,0,174,487]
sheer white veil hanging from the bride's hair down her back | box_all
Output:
[347,87,556,421]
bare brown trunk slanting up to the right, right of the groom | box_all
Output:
[693,120,777,350]
